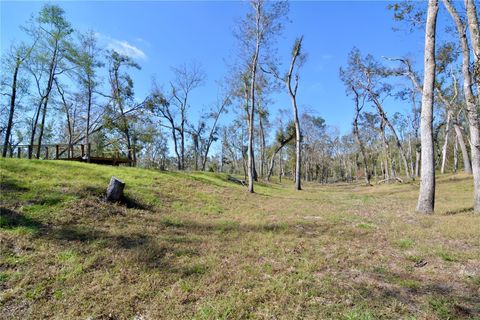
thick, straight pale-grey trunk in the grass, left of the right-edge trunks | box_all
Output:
[417,0,438,213]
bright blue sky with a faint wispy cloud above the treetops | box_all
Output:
[0,1,423,133]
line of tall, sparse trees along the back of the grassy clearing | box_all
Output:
[0,0,480,213]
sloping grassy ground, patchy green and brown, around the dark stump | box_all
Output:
[0,159,480,319]
